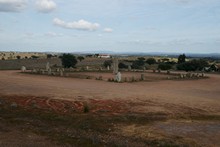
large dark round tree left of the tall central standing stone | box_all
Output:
[60,54,77,68]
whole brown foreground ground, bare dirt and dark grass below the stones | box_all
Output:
[0,71,220,146]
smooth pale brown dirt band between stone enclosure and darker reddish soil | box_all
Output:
[0,71,220,113]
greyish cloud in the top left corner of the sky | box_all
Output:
[0,0,27,12]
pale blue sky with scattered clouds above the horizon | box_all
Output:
[0,0,220,53]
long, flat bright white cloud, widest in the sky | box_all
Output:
[53,18,100,31]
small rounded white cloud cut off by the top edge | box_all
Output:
[36,0,57,13]
